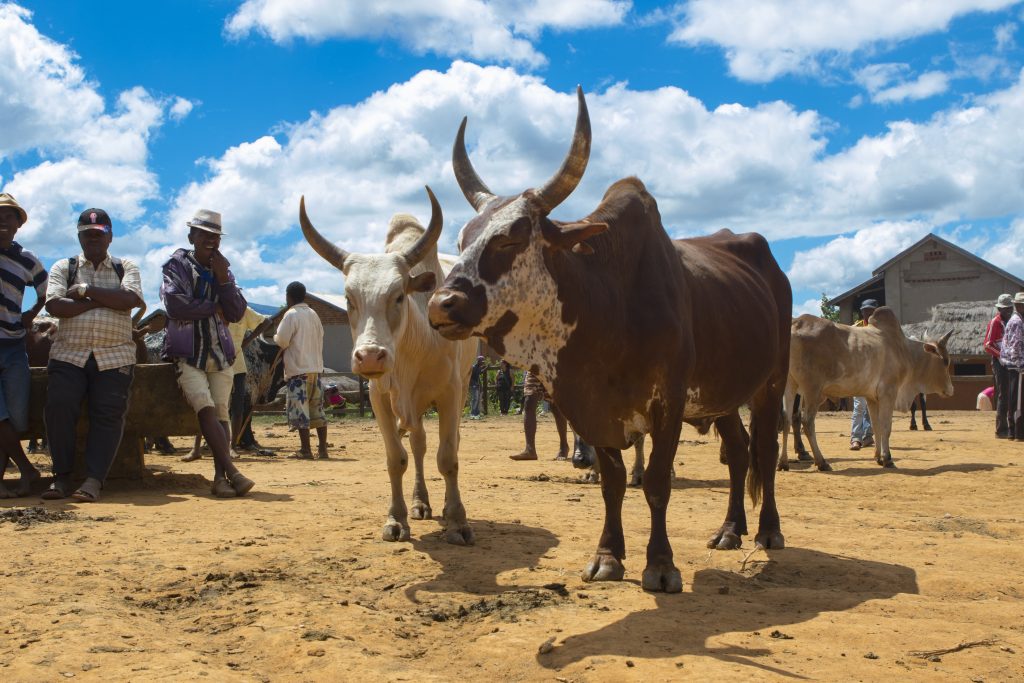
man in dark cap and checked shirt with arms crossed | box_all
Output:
[43,209,142,502]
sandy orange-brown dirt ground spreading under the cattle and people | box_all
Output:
[0,412,1024,682]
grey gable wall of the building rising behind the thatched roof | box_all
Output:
[885,241,1017,324]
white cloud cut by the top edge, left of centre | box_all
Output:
[226,0,632,67]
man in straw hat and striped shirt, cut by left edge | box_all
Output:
[0,193,46,498]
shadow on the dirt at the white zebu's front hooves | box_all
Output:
[406,520,558,602]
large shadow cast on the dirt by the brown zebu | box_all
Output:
[537,548,919,678]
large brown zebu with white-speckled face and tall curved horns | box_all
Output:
[430,89,792,592]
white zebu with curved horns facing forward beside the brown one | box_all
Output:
[299,187,476,545]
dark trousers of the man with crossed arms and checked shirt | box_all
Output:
[45,355,135,481]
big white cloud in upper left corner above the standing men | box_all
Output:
[0,4,183,248]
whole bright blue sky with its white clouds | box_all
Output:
[0,0,1024,311]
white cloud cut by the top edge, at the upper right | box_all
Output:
[669,0,1018,82]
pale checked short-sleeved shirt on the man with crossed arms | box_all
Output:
[46,254,142,371]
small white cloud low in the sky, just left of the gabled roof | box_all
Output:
[786,221,931,296]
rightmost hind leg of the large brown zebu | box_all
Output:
[753,385,782,549]
